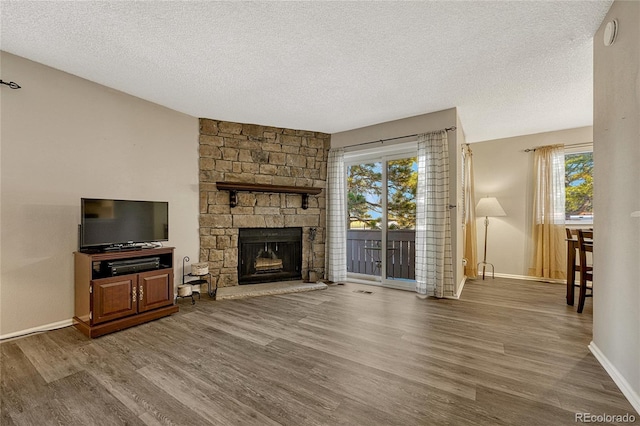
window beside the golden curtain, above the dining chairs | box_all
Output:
[564,146,593,225]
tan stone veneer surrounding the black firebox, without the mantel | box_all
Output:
[200,118,331,287]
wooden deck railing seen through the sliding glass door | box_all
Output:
[347,229,416,280]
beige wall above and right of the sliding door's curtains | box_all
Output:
[331,108,464,291]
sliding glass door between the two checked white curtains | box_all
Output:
[347,146,418,290]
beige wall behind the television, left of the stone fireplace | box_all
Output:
[0,52,199,337]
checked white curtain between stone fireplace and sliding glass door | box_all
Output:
[324,149,347,282]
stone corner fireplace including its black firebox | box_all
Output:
[199,119,330,287]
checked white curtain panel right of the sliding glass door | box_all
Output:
[416,131,455,297]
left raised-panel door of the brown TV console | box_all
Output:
[91,275,138,325]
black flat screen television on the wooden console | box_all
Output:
[80,198,169,250]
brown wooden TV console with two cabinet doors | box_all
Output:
[73,247,178,338]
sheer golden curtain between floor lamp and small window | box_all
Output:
[529,145,567,279]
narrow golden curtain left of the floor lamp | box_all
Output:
[462,144,478,278]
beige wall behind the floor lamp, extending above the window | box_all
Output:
[471,127,593,276]
